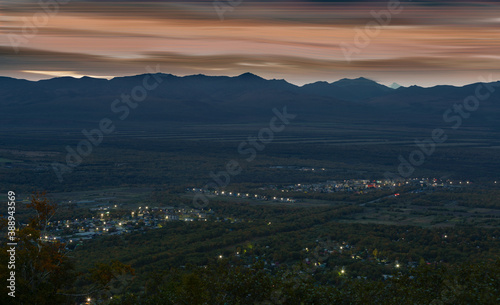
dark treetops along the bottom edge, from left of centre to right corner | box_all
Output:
[109,260,500,305]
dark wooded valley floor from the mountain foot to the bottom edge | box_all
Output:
[0,125,500,305]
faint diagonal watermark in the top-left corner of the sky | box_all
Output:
[7,0,72,53]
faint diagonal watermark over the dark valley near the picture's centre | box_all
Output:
[193,107,297,208]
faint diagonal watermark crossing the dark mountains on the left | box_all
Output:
[52,65,163,183]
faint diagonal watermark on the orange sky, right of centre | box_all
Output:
[340,0,403,62]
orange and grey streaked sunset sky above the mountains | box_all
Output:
[0,0,500,87]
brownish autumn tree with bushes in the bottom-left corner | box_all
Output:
[0,193,133,305]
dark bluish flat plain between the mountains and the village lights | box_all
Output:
[0,120,500,226]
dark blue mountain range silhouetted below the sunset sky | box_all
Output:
[0,73,500,129]
